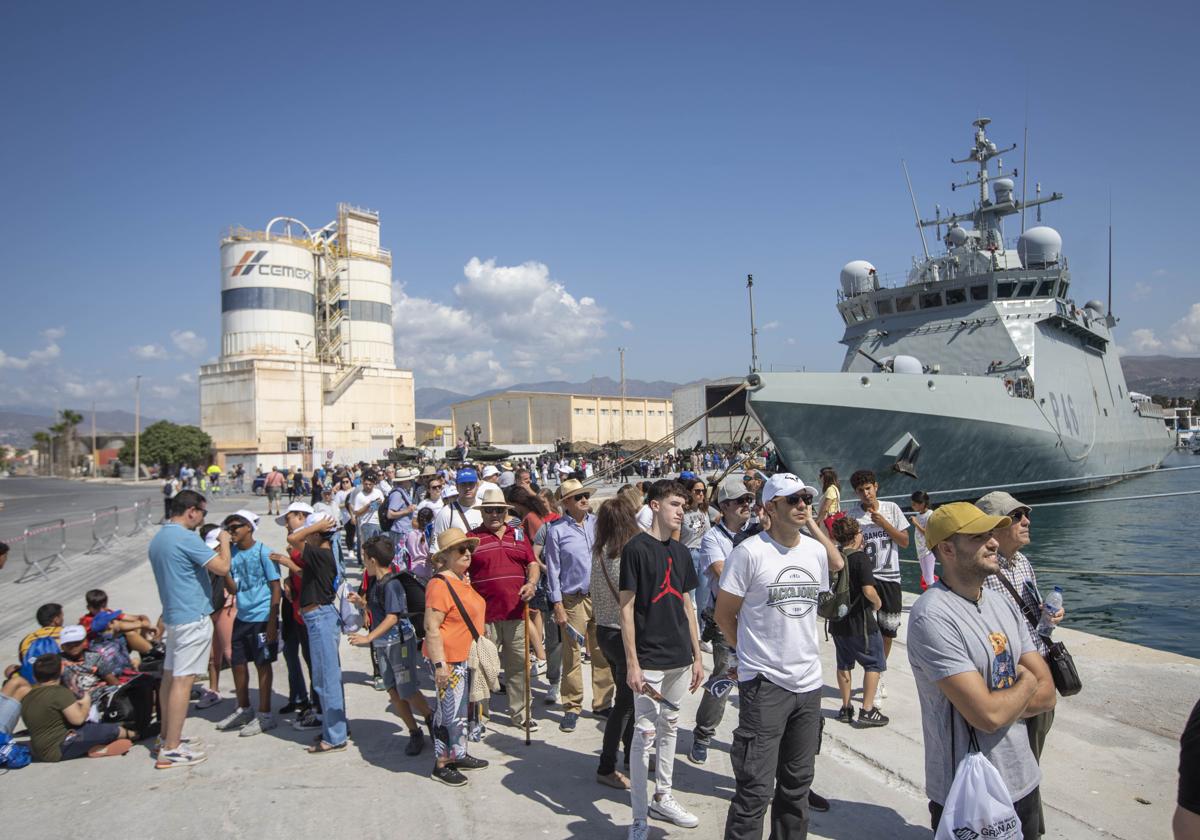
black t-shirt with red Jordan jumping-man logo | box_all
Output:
[620,533,696,671]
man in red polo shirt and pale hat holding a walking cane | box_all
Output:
[469,486,540,730]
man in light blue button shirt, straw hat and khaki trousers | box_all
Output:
[542,479,613,732]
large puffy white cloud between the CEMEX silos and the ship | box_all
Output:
[392,257,605,391]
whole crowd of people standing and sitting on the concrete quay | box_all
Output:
[0,453,1113,839]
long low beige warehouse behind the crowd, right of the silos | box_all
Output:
[450,391,674,449]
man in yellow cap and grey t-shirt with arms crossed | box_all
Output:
[908,503,1055,840]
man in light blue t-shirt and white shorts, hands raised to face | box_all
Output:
[149,490,229,769]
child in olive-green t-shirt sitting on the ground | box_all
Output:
[20,653,138,761]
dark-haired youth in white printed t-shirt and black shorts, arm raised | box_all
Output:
[846,469,908,691]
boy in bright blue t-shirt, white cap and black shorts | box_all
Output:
[217,511,282,738]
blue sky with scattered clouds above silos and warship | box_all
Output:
[0,2,1200,419]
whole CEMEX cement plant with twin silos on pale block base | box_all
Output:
[199,204,415,475]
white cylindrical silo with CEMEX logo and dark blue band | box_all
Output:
[221,220,316,359]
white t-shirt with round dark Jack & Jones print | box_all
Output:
[720,532,829,692]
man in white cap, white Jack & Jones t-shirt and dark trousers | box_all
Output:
[714,473,844,840]
